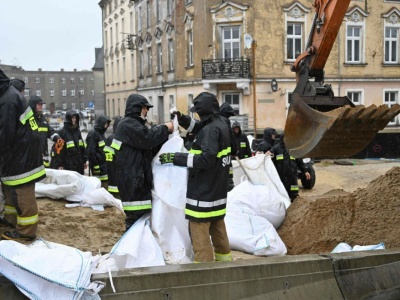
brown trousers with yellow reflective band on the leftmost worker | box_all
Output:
[2,183,39,237]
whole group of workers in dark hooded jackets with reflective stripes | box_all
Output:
[0,70,310,262]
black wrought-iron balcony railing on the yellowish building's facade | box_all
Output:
[201,57,250,79]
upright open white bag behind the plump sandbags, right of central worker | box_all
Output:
[232,154,291,209]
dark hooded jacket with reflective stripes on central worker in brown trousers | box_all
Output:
[173,93,231,222]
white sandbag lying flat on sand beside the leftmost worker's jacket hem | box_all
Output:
[35,169,101,202]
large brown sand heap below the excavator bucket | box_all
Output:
[278,167,400,255]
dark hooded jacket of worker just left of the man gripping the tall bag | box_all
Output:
[86,115,111,181]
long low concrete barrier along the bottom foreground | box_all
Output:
[0,249,400,300]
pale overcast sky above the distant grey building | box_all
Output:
[0,0,102,71]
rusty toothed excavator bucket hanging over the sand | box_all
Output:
[284,93,400,158]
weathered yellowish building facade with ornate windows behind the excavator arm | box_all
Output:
[100,0,400,134]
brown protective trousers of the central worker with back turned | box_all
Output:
[189,219,232,263]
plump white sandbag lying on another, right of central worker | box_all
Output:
[228,180,286,228]
